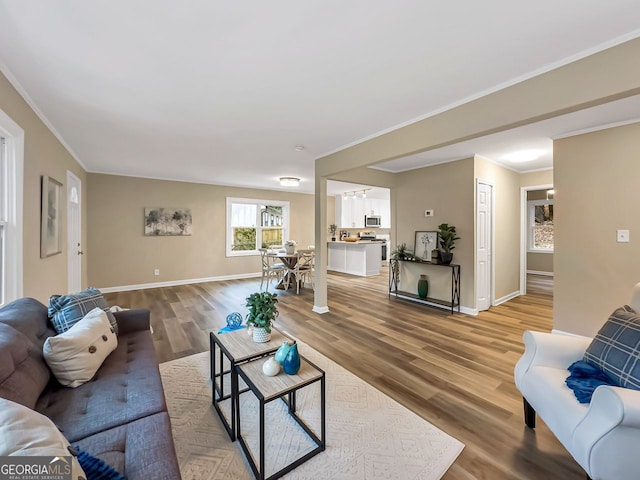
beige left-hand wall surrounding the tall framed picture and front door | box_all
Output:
[0,73,87,303]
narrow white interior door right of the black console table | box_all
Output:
[476,181,493,311]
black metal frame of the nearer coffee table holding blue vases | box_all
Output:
[236,356,326,480]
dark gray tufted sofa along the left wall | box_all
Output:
[0,298,180,480]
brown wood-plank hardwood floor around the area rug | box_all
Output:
[106,268,584,480]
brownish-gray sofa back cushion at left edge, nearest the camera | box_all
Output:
[0,323,51,408]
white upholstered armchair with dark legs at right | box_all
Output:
[515,283,640,480]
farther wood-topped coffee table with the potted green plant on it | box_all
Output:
[209,327,291,442]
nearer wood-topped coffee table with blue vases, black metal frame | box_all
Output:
[235,356,326,480]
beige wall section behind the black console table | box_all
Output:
[392,158,475,308]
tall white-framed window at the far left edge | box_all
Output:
[0,110,24,305]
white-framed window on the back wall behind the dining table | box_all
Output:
[227,197,289,256]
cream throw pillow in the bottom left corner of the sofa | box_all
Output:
[0,398,86,480]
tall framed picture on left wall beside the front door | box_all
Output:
[40,175,62,258]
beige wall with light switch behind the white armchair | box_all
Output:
[554,123,640,336]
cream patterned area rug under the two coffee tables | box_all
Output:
[160,342,464,480]
